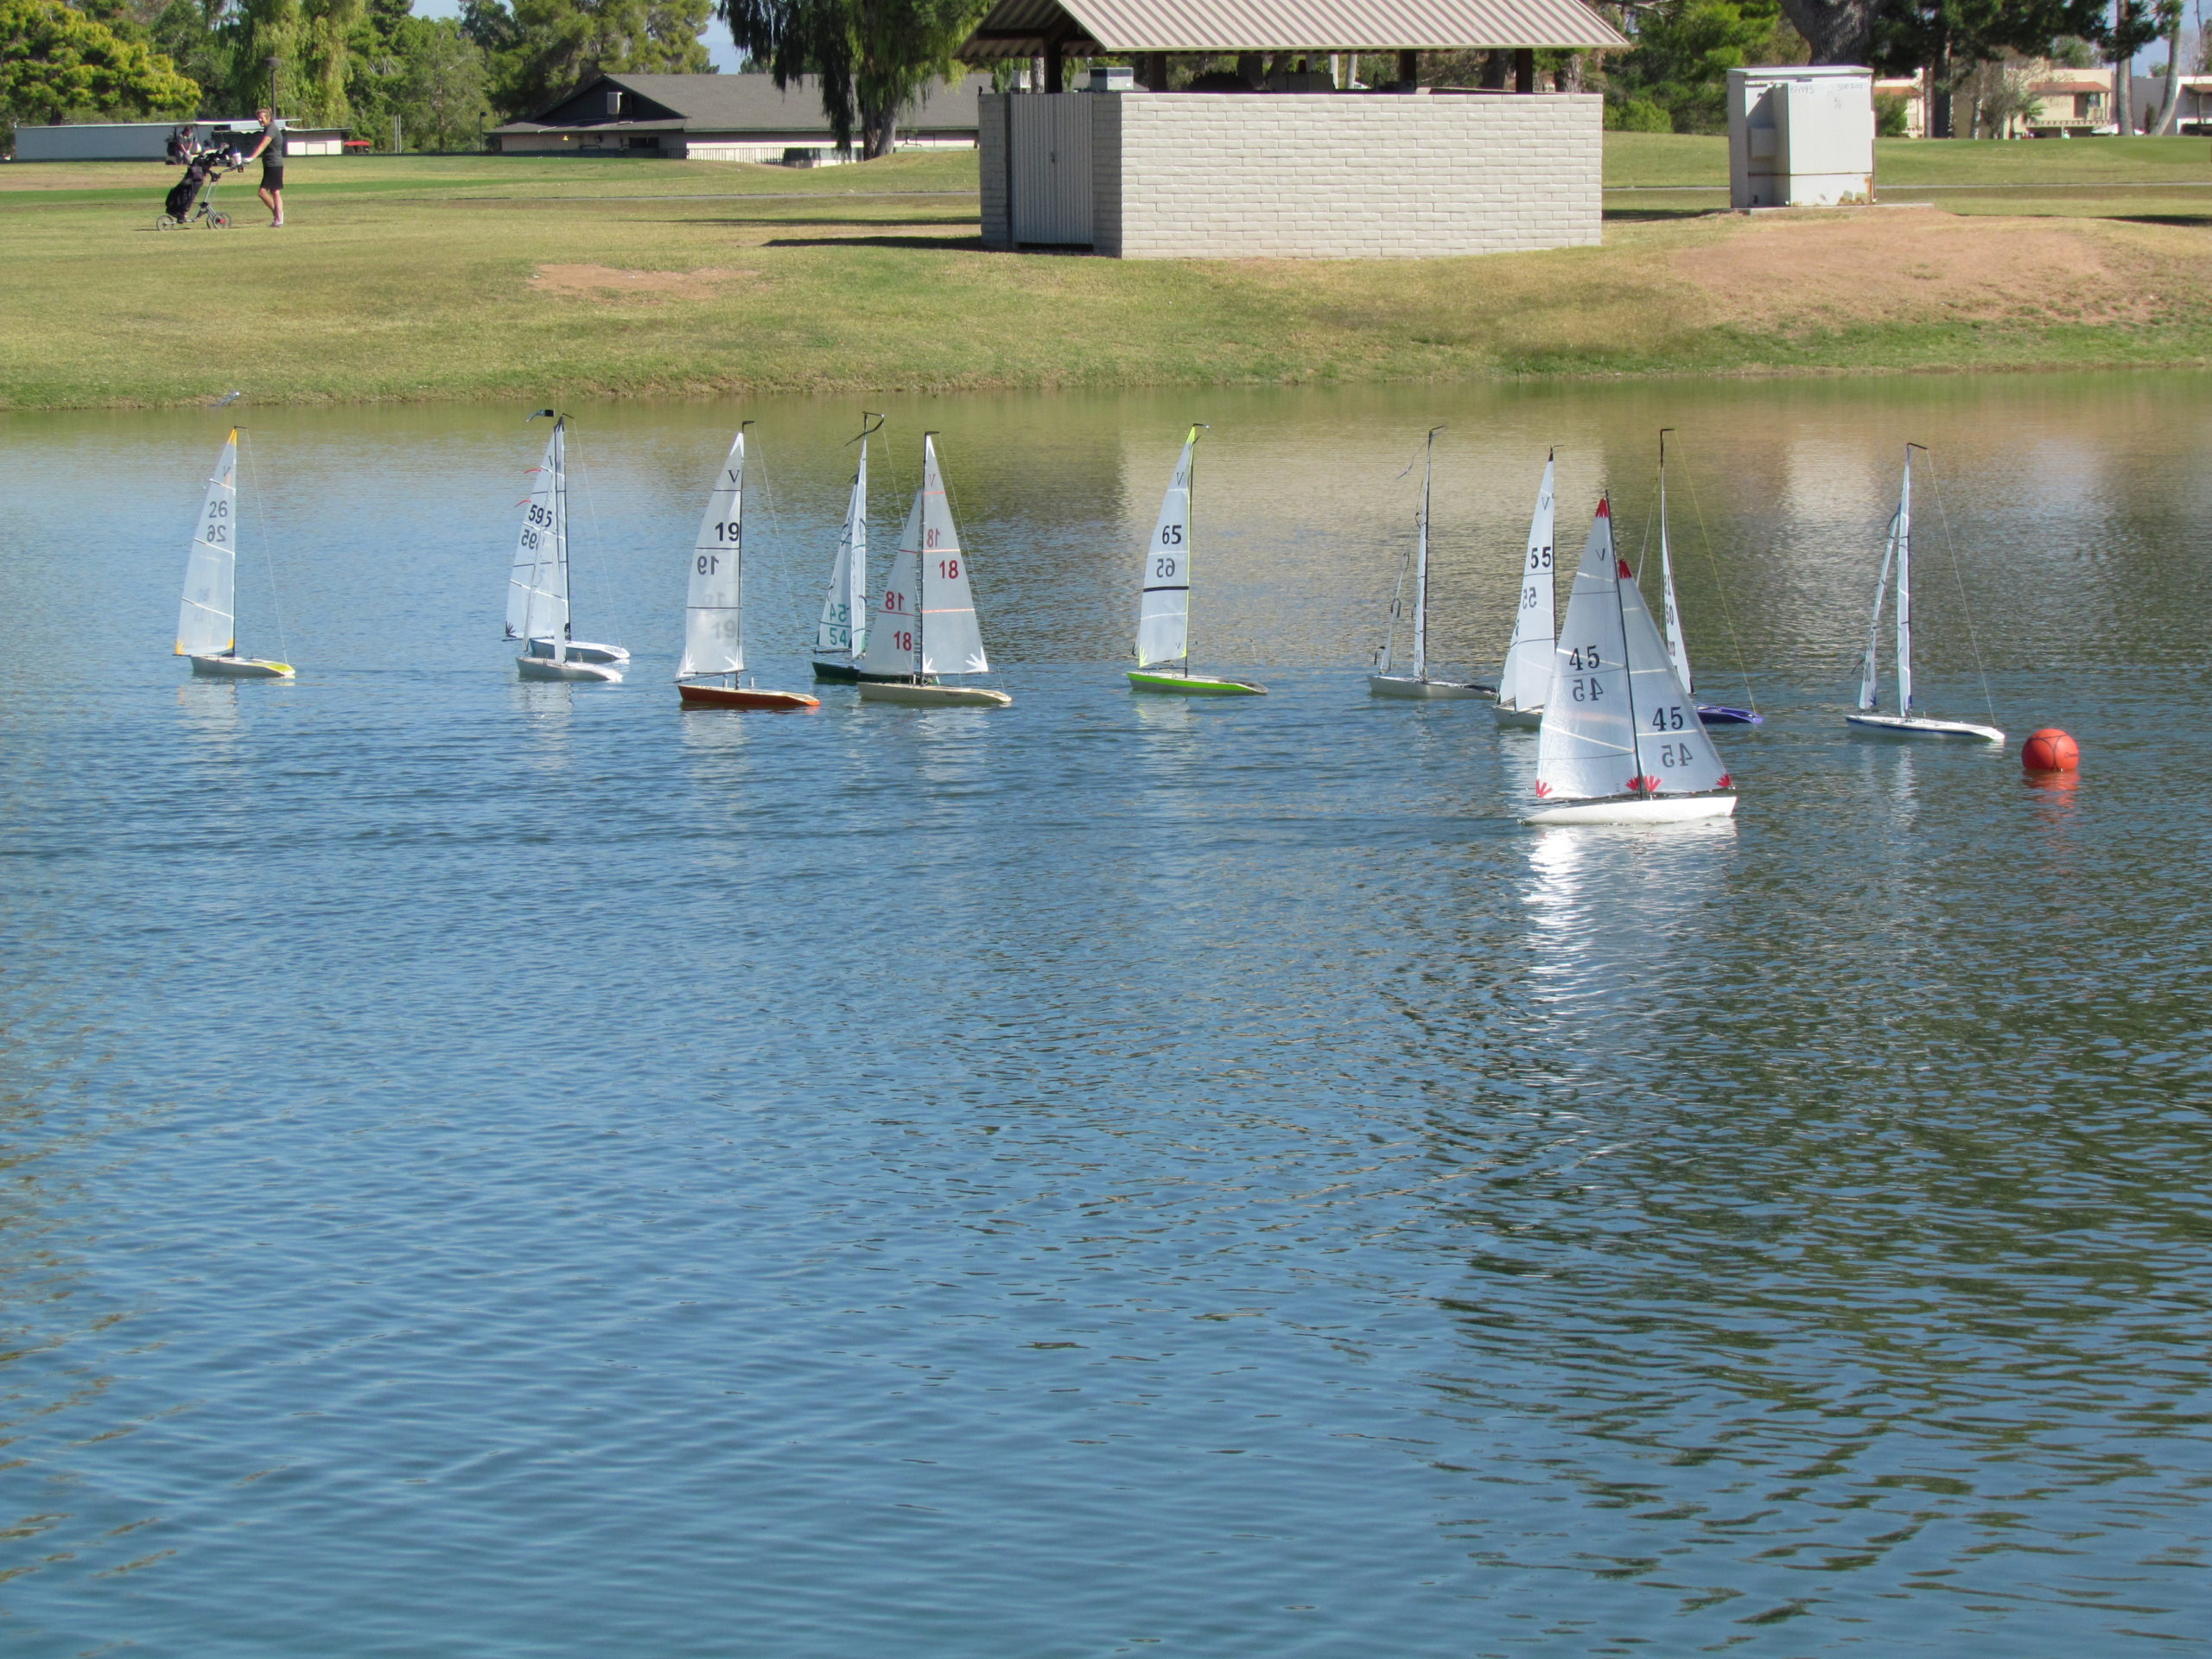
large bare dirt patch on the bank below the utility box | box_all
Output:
[1672,208,2172,329]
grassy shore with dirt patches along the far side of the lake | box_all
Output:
[0,135,2212,410]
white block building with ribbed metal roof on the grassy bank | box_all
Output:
[960,0,1628,259]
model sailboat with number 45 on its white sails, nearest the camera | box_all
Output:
[1524,502,1737,823]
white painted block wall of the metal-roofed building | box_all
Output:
[1088,93,1604,259]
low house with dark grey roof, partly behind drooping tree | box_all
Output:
[489,75,988,163]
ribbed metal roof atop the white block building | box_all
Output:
[960,0,1628,62]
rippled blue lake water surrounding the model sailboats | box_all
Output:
[0,376,2212,1659]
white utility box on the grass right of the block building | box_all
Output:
[1727,64,1873,208]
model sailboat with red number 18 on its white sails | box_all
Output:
[861,431,1013,708]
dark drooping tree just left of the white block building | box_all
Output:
[719,0,991,159]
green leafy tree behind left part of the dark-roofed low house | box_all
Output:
[460,0,715,115]
